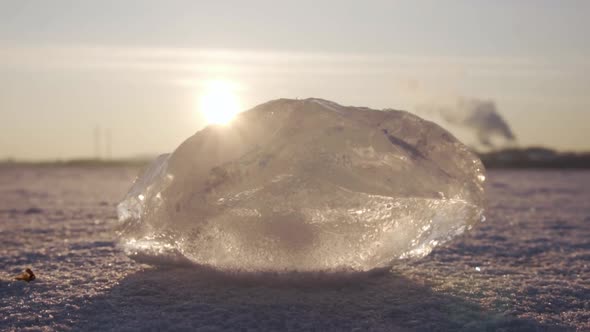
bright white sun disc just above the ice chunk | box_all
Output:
[199,80,240,125]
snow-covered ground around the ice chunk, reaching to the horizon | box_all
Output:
[0,167,590,331]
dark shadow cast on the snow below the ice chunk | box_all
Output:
[72,267,567,331]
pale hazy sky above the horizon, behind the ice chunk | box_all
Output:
[0,0,590,159]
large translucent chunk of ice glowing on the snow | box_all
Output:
[118,99,485,271]
